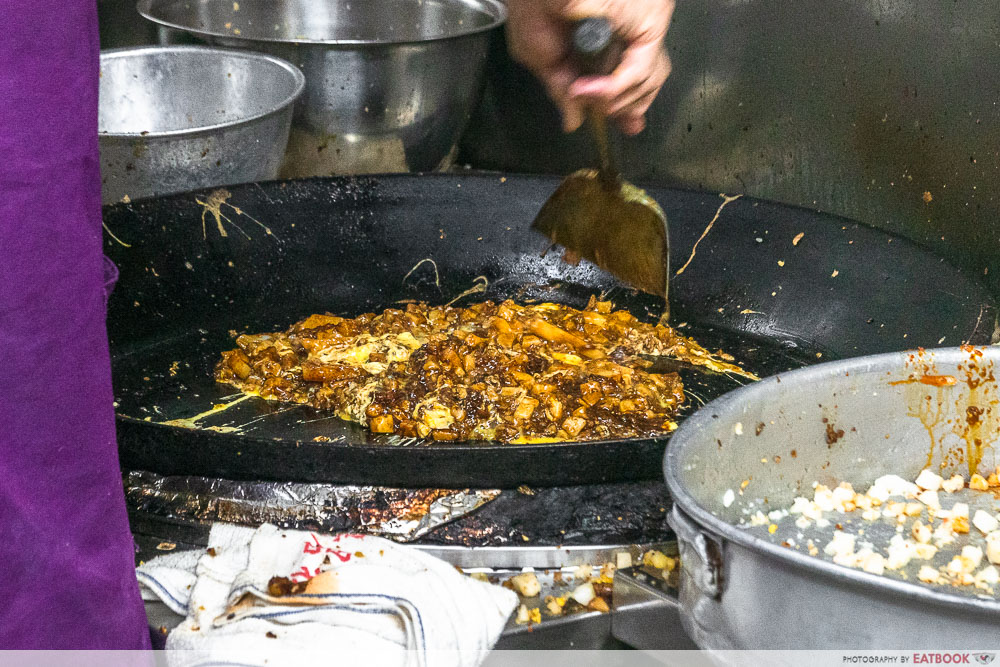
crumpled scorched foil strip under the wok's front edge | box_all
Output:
[124,470,500,542]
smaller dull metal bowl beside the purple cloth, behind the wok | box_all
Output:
[98,46,305,204]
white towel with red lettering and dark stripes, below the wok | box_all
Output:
[137,524,517,667]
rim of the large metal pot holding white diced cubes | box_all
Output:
[663,347,1000,615]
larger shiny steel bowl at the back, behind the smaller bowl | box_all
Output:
[138,0,506,177]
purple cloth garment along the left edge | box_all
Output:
[0,0,149,649]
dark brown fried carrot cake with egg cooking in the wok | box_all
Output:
[215,297,753,442]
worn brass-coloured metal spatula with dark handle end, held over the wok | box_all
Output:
[532,17,670,322]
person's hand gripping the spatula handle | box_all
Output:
[507,0,674,134]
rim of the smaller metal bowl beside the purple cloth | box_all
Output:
[97,46,306,140]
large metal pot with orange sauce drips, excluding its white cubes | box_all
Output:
[664,346,1000,648]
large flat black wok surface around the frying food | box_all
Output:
[105,174,995,487]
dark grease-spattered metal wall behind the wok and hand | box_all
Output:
[460,0,1000,291]
